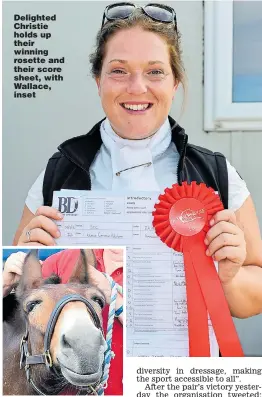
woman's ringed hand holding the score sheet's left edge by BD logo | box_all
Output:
[17,206,63,246]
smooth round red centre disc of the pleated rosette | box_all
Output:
[169,198,207,236]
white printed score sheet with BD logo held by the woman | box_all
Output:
[53,190,219,357]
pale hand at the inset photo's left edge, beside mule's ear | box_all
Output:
[3,252,26,296]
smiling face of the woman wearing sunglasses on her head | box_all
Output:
[96,27,177,139]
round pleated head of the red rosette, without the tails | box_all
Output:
[153,182,224,252]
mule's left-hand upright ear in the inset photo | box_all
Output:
[16,250,43,296]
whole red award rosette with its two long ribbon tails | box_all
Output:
[153,182,244,357]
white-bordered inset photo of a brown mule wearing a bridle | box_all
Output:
[2,247,125,396]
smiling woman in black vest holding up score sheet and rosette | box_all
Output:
[15,3,262,350]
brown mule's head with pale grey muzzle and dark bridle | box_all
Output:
[17,250,107,394]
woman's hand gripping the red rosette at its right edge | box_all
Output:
[205,210,247,284]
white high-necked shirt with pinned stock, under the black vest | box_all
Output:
[25,119,250,213]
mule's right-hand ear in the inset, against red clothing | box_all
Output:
[69,249,96,284]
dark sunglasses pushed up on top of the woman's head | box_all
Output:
[101,2,177,32]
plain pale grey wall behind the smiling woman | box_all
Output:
[3,1,262,356]
